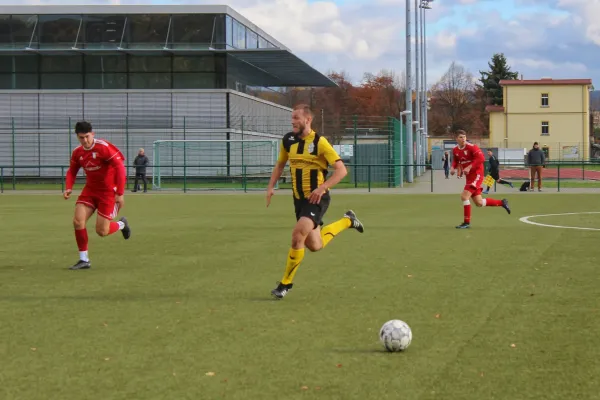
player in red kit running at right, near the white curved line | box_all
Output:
[450,130,510,229]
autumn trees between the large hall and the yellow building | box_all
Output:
[252,53,518,141]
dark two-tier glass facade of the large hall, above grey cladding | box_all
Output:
[0,14,276,90]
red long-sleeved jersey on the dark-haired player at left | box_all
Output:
[66,139,126,196]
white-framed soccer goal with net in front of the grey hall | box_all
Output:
[152,138,279,190]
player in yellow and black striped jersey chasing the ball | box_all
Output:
[266,104,364,299]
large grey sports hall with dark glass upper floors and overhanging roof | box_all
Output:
[0,5,335,183]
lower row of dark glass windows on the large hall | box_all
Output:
[0,54,227,90]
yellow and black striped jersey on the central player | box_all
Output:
[278,131,340,199]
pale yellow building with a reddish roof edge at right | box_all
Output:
[486,78,592,160]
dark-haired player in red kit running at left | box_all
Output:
[63,121,131,270]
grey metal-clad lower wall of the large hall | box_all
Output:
[0,90,291,176]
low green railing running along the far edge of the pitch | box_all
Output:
[0,161,600,193]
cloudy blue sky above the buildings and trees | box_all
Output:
[9,0,600,87]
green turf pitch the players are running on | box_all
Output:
[0,192,600,400]
